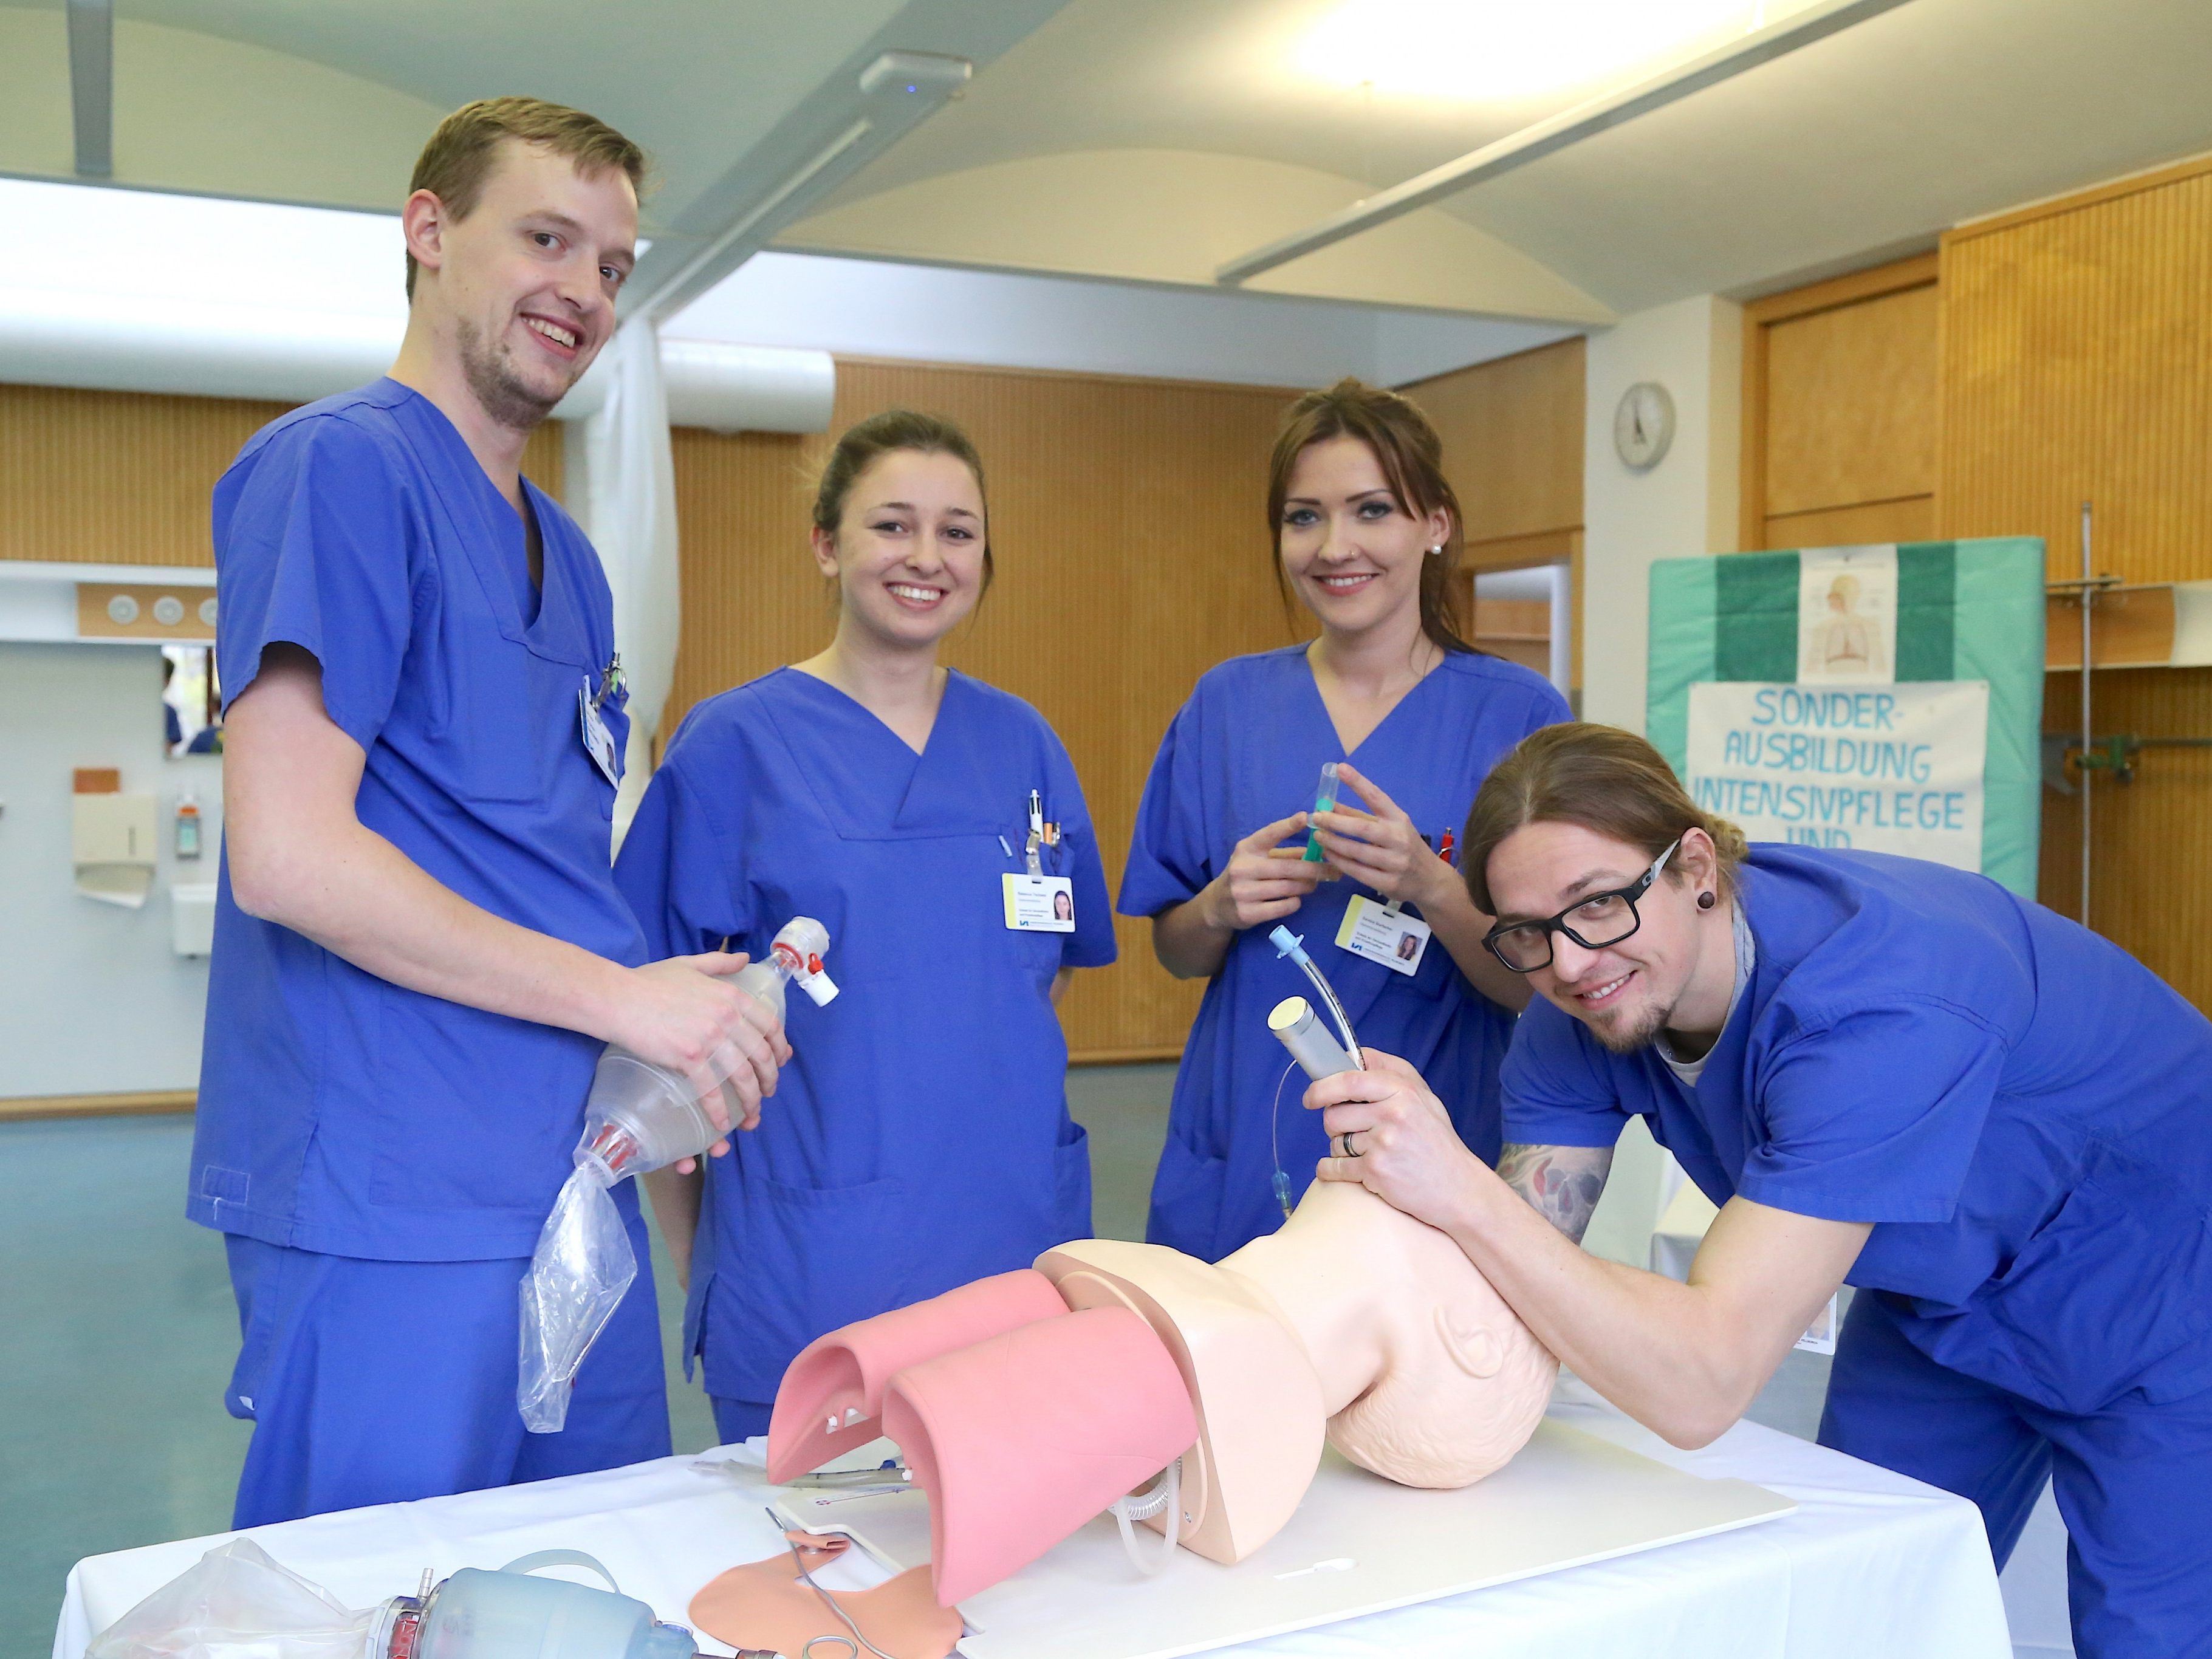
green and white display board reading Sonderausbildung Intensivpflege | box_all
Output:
[1646,535,2044,898]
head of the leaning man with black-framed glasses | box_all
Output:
[1464,723,1745,1053]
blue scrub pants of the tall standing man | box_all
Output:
[224,1217,668,1527]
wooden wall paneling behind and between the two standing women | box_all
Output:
[668,361,1298,1059]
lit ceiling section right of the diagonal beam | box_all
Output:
[779,0,2212,323]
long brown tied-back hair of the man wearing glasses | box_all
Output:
[1460,721,1745,916]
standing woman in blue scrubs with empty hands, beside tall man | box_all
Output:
[615,411,1115,1440]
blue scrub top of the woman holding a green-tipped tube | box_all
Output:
[1119,646,1570,1261]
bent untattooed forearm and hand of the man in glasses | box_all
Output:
[1305,1051,1871,1446]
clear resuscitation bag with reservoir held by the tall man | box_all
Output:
[515,916,836,1434]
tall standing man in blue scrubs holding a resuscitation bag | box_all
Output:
[190,97,787,1527]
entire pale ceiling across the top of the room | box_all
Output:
[0,0,2212,338]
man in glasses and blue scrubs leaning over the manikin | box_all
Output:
[1309,725,2212,1659]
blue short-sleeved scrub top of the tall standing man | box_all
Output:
[190,380,644,1261]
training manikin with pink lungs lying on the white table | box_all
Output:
[767,1181,1557,1604]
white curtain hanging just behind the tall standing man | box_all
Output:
[570,323,681,847]
